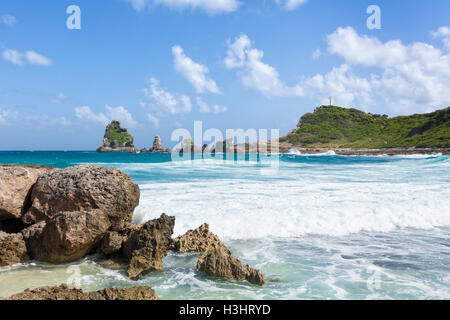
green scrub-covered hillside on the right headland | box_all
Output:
[280,106,450,149]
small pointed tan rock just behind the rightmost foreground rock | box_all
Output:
[171,223,231,254]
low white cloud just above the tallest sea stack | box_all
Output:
[74,105,137,128]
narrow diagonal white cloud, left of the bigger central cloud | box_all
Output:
[172,46,220,93]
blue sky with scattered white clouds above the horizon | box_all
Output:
[0,0,450,150]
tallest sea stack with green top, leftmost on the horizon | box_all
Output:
[97,120,136,153]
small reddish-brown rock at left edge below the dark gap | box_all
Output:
[0,231,29,267]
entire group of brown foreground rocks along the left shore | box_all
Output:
[0,165,265,300]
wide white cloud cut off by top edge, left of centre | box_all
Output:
[126,0,240,14]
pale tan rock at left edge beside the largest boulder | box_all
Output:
[0,165,51,220]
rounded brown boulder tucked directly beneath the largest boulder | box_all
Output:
[22,209,110,263]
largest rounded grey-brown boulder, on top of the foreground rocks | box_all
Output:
[22,164,140,230]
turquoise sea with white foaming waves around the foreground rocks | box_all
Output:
[0,152,450,299]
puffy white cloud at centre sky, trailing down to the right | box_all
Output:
[224,34,304,97]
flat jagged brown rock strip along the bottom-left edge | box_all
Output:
[0,284,159,300]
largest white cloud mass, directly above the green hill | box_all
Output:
[303,27,450,114]
